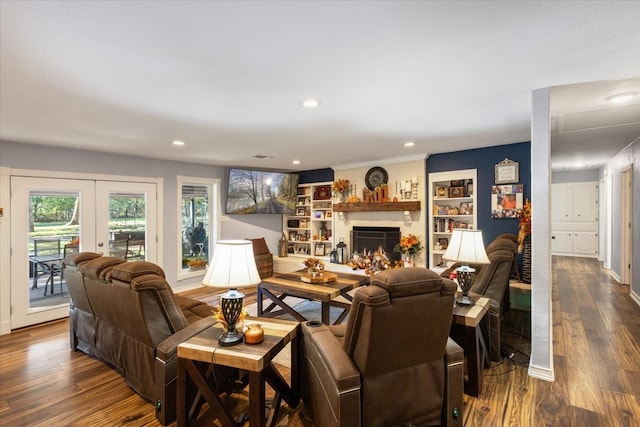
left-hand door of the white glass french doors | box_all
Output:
[10,177,95,329]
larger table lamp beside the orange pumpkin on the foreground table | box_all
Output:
[202,240,260,346]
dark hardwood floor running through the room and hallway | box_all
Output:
[0,257,640,427]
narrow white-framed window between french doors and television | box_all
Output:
[177,176,220,280]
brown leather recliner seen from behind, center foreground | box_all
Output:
[301,268,464,427]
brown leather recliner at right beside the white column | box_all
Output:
[441,236,516,362]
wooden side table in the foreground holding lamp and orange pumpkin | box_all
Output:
[177,318,300,427]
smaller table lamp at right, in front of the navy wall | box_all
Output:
[442,228,491,305]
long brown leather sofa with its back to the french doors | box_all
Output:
[64,252,233,425]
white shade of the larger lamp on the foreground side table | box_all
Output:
[202,240,260,289]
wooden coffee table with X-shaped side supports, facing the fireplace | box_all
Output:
[257,270,369,325]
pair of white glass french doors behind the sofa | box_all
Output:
[11,176,157,329]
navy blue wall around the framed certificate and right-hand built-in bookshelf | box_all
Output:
[427,142,531,245]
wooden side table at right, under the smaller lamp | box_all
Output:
[453,297,490,397]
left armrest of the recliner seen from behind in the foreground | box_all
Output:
[301,322,361,427]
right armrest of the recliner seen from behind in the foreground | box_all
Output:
[442,338,464,426]
